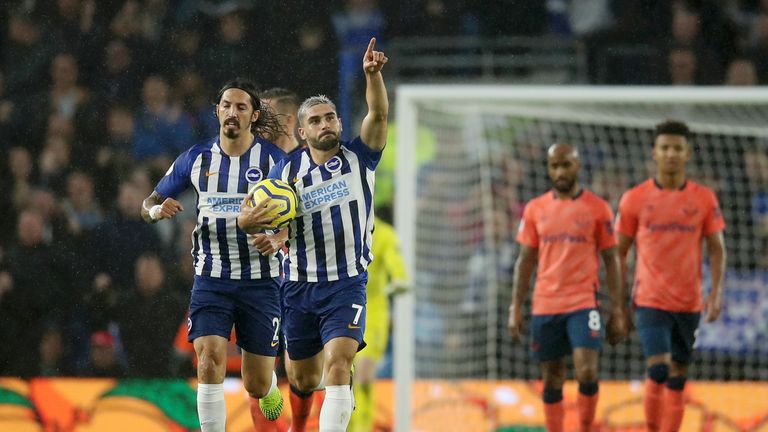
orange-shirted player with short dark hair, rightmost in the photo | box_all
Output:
[616,121,725,431]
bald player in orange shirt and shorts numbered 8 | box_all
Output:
[509,144,626,432]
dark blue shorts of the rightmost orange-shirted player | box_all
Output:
[635,307,701,364]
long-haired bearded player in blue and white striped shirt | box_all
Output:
[141,80,283,432]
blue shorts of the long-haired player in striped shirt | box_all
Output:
[187,276,280,357]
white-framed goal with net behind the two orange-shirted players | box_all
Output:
[393,86,768,430]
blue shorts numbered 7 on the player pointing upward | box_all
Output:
[283,273,368,360]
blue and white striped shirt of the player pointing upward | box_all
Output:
[269,137,381,282]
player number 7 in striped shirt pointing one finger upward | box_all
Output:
[246,39,389,432]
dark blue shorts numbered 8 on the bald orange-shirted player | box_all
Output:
[531,309,603,361]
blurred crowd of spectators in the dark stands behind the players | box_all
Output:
[0,0,768,377]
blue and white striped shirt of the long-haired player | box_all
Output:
[155,137,284,280]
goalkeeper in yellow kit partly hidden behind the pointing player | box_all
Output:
[347,209,406,432]
